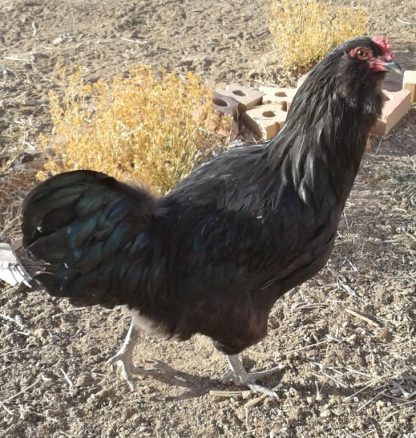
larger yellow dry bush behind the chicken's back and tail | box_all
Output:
[40,66,232,193]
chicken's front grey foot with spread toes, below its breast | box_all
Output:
[222,354,284,398]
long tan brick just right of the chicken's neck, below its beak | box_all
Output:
[370,90,411,135]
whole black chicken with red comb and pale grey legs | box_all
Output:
[22,37,400,393]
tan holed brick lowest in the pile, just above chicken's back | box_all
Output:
[243,103,287,140]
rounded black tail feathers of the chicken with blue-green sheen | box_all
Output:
[22,170,154,307]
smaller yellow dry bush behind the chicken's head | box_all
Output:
[270,0,368,68]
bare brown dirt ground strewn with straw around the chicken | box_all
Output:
[0,0,416,438]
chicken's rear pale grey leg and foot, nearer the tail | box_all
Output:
[107,321,146,391]
